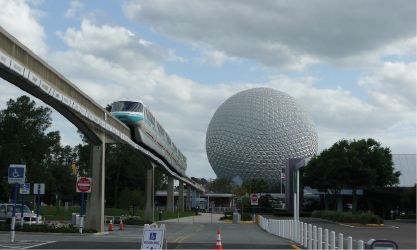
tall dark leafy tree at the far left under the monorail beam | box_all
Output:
[0,96,59,200]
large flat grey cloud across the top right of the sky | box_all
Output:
[123,0,416,70]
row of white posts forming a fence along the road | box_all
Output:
[258,216,364,250]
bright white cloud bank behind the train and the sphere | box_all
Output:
[48,20,415,177]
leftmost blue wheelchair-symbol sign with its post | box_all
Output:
[7,164,26,243]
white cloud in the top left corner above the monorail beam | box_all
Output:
[0,0,48,56]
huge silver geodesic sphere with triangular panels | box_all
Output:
[206,88,317,188]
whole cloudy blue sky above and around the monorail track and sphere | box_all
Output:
[0,0,417,178]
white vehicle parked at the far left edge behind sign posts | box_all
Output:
[0,203,42,224]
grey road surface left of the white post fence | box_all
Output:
[0,214,293,249]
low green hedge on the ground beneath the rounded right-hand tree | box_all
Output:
[311,210,384,224]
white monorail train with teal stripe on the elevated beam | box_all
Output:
[111,101,187,175]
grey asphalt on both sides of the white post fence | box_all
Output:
[0,214,416,249]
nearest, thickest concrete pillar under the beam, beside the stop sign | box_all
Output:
[86,142,106,232]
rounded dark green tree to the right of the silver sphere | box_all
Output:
[303,139,400,211]
